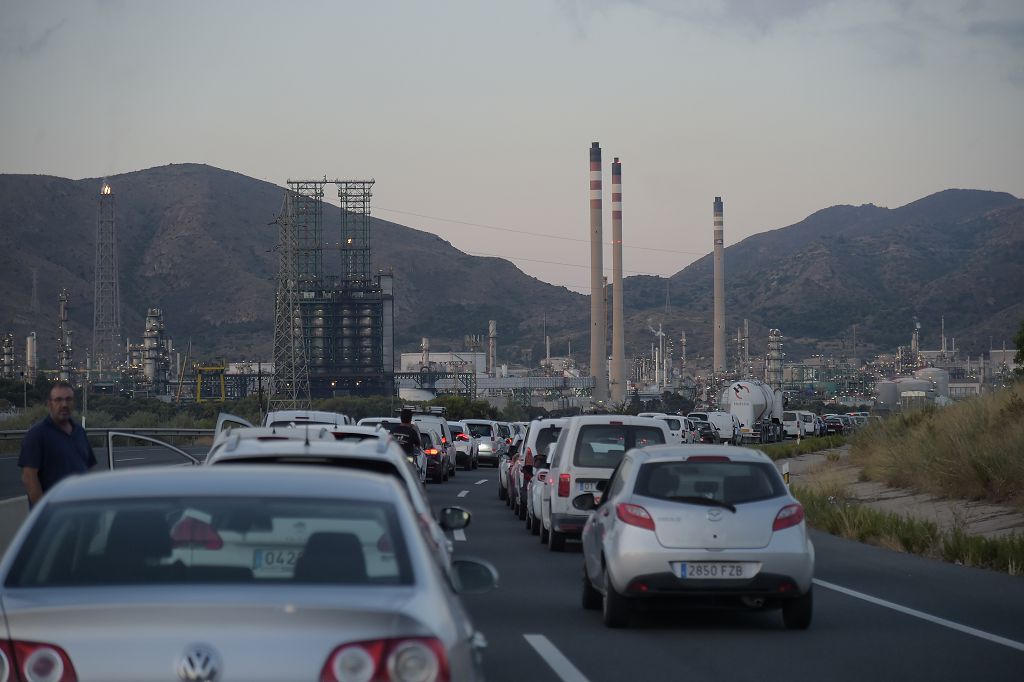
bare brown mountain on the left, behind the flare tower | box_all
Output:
[0,164,589,366]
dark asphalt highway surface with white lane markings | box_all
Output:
[0,447,1024,682]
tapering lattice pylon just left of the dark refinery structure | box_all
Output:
[267,189,311,410]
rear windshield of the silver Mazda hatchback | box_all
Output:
[633,462,785,505]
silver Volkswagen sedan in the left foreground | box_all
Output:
[0,466,497,682]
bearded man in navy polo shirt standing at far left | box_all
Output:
[17,381,96,509]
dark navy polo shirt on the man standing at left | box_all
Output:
[17,415,96,493]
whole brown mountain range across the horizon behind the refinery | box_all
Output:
[0,164,1024,372]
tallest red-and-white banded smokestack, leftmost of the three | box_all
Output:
[590,142,608,401]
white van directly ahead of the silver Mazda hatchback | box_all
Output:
[541,415,669,552]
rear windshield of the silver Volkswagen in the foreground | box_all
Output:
[5,496,414,588]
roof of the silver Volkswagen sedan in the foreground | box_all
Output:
[45,465,404,504]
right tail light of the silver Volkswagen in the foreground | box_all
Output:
[321,637,450,682]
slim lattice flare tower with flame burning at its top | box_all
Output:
[92,183,123,371]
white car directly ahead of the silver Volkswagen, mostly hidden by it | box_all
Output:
[204,426,453,564]
